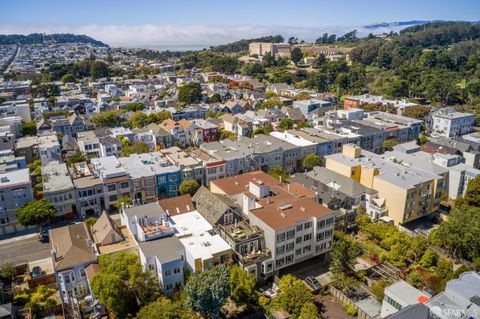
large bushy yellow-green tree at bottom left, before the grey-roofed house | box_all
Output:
[91,252,160,318]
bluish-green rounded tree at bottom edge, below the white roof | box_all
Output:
[184,264,230,318]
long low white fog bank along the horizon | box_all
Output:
[0,24,412,47]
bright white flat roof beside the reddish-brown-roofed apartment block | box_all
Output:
[170,210,230,260]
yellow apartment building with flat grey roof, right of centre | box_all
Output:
[325,144,445,225]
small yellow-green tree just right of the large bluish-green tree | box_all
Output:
[229,265,258,307]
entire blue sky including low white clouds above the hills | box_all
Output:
[0,0,480,46]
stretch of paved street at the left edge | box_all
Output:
[0,236,50,265]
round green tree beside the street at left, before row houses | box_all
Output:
[17,199,57,227]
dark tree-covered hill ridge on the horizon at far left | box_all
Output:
[0,33,108,46]
